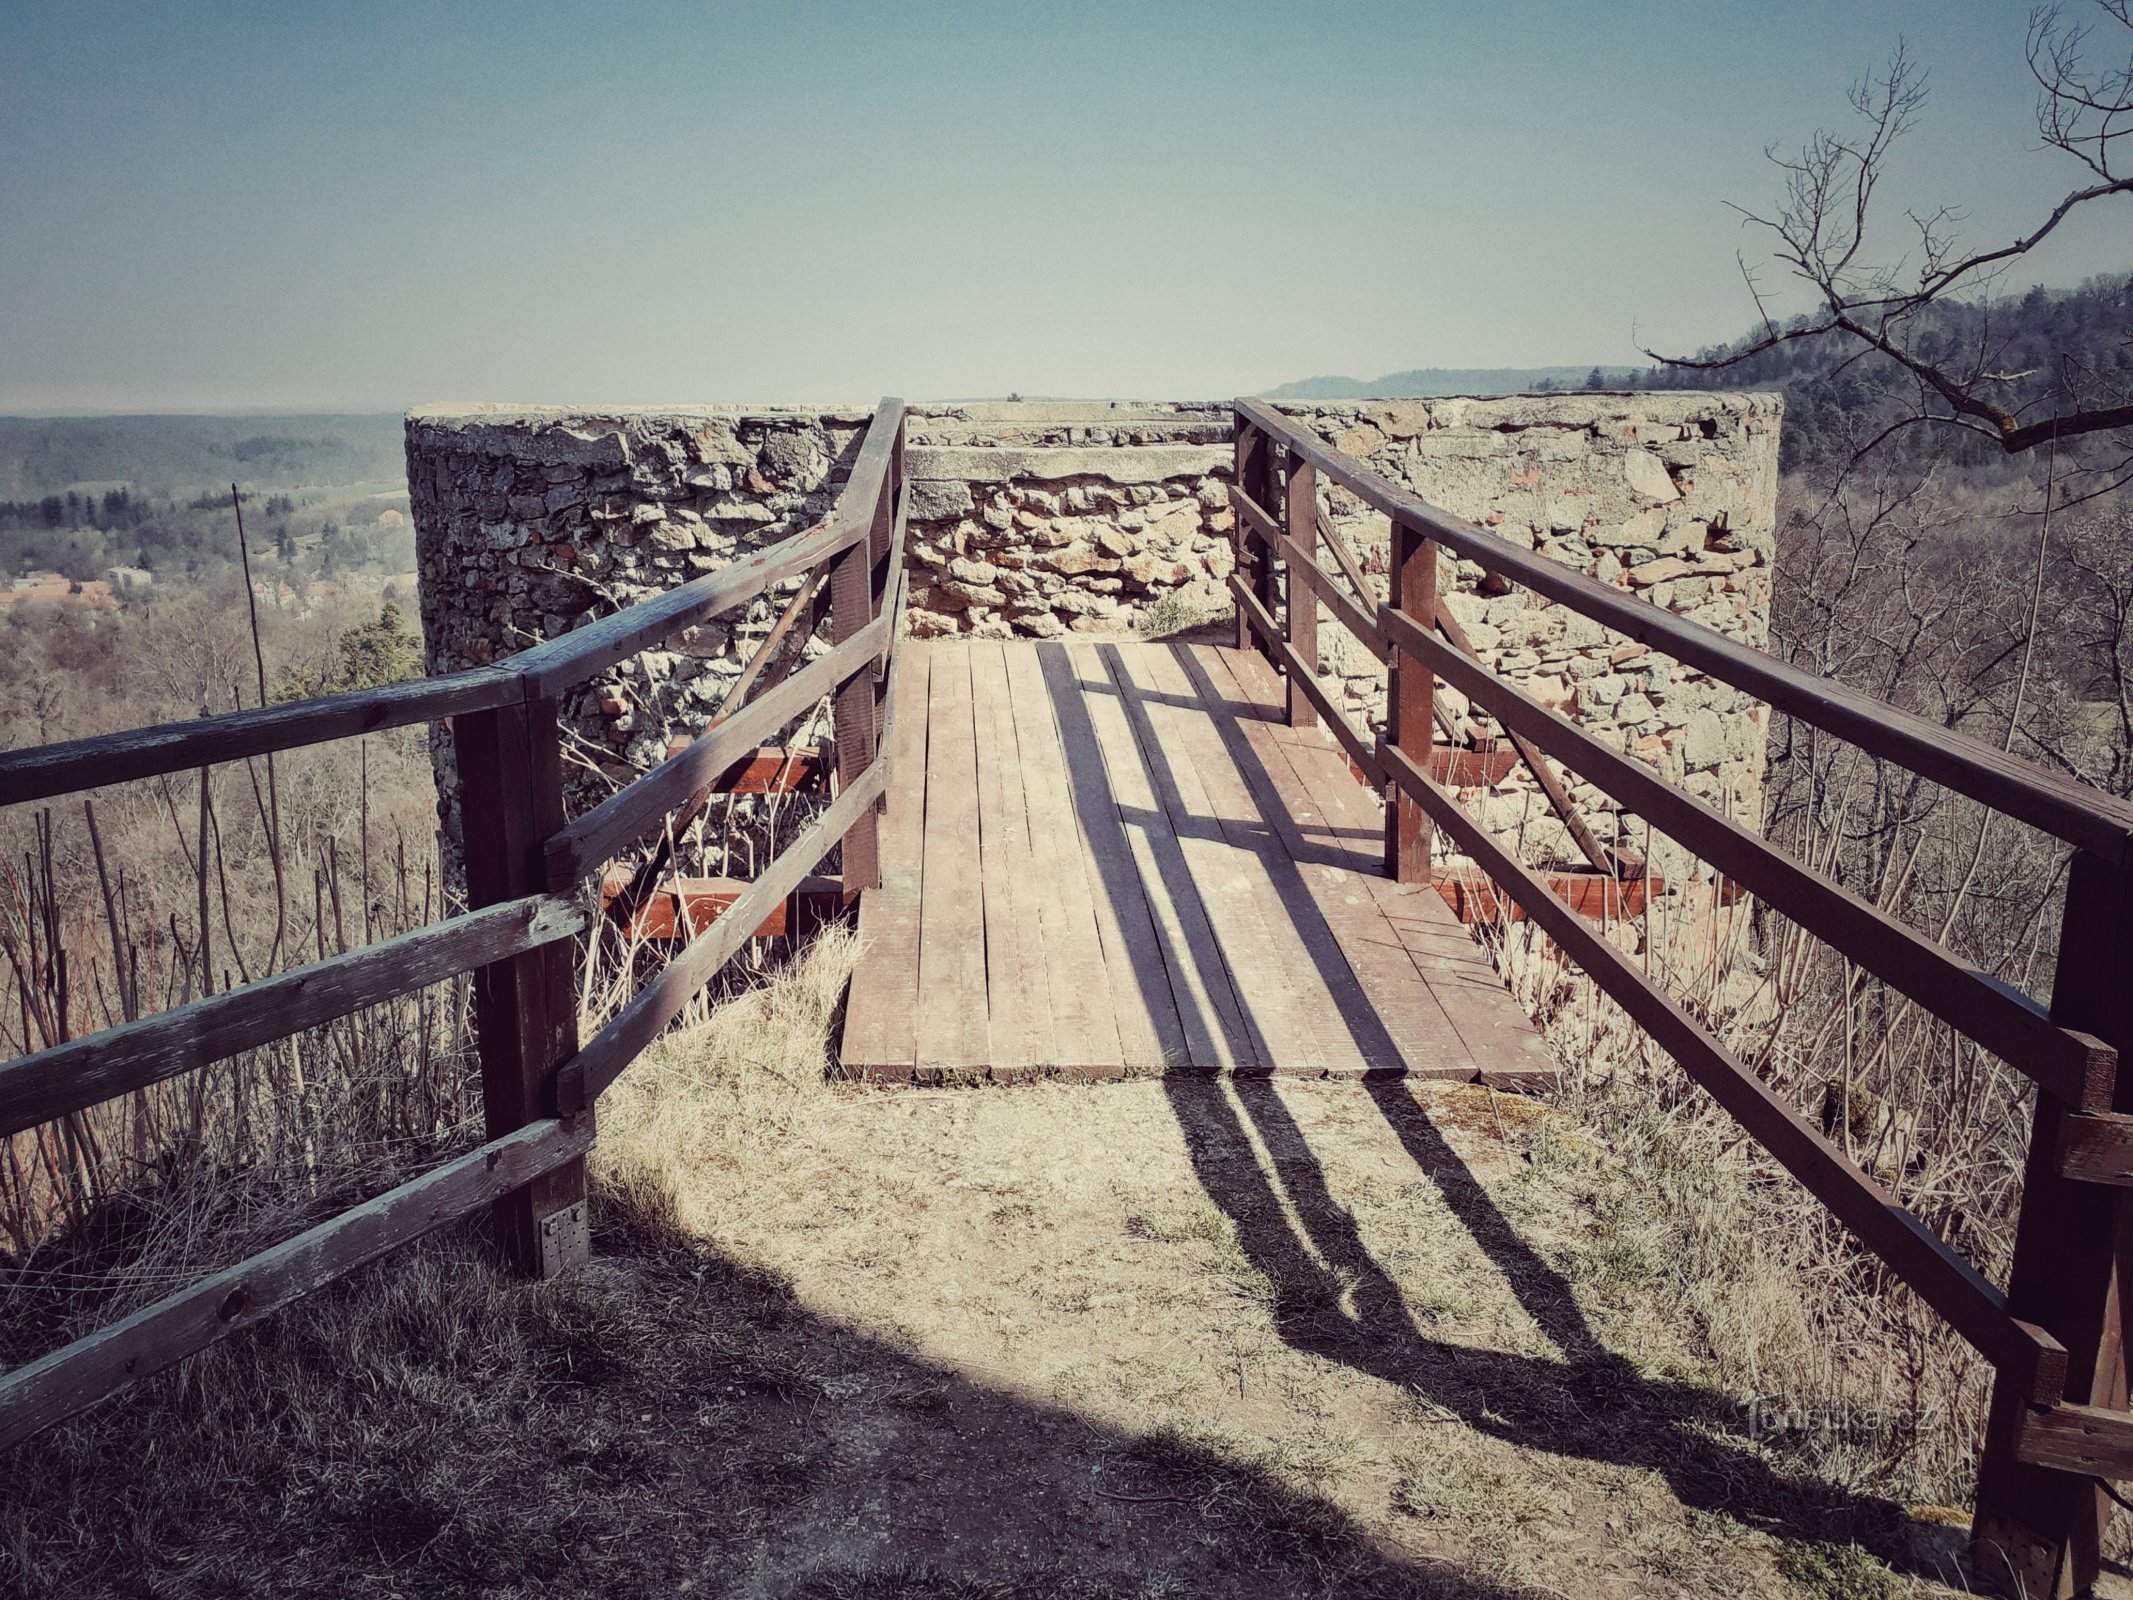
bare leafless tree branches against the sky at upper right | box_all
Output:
[1645,0,2133,454]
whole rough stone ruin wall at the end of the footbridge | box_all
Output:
[407,393,1781,879]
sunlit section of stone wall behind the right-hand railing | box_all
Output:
[1284,393,1783,881]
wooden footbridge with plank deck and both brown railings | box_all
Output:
[0,399,2133,1596]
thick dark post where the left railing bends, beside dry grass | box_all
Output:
[452,700,591,1278]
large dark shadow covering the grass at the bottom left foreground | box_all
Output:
[0,1225,1552,1600]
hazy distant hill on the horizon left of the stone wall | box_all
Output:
[0,412,407,499]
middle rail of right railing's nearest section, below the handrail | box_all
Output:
[1386,612,2118,1111]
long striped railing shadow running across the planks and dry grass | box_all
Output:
[1039,646,1945,1577]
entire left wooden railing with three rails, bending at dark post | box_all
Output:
[0,399,904,1449]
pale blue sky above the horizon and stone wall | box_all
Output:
[0,0,2133,412]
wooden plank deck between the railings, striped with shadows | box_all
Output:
[840,640,1555,1086]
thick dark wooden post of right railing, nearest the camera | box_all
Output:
[1971,851,2133,1600]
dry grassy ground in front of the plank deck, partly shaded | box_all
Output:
[0,934,1960,1600]
